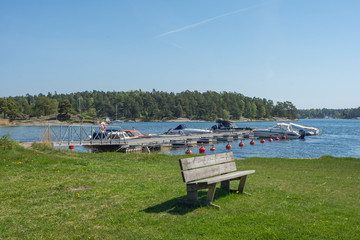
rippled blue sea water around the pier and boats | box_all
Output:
[0,119,360,158]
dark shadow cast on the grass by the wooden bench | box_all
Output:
[142,188,229,215]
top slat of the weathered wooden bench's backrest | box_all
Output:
[180,152,234,171]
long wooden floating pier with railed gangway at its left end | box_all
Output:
[44,125,250,152]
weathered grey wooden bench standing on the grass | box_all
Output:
[179,152,255,207]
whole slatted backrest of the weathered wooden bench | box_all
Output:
[179,152,236,182]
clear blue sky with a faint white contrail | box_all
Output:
[0,0,360,109]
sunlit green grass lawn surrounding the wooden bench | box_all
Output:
[0,142,360,239]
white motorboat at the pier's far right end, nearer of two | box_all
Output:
[253,123,305,139]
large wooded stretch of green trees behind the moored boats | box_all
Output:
[0,90,298,121]
